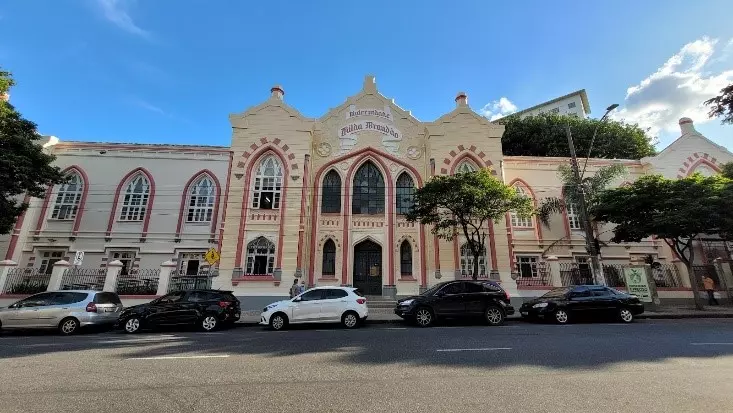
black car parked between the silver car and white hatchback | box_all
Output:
[118,290,241,333]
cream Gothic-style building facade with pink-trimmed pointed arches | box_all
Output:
[2,76,733,300]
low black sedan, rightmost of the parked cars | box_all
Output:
[519,285,644,324]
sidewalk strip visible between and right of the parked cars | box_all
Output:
[239,306,733,324]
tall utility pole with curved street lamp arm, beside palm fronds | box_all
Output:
[565,103,618,285]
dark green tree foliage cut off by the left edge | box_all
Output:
[0,70,64,234]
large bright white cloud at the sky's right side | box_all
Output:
[612,37,733,137]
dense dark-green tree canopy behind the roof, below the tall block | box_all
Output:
[497,113,656,159]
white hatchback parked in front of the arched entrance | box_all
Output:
[260,287,369,330]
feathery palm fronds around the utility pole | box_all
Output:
[537,164,626,227]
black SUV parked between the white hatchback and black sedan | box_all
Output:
[394,281,514,327]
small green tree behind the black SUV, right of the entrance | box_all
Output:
[407,169,533,279]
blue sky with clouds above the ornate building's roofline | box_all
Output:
[0,0,733,148]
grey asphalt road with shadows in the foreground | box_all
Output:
[0,320,733,413]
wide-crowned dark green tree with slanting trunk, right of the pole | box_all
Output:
[593,174,731,309]
